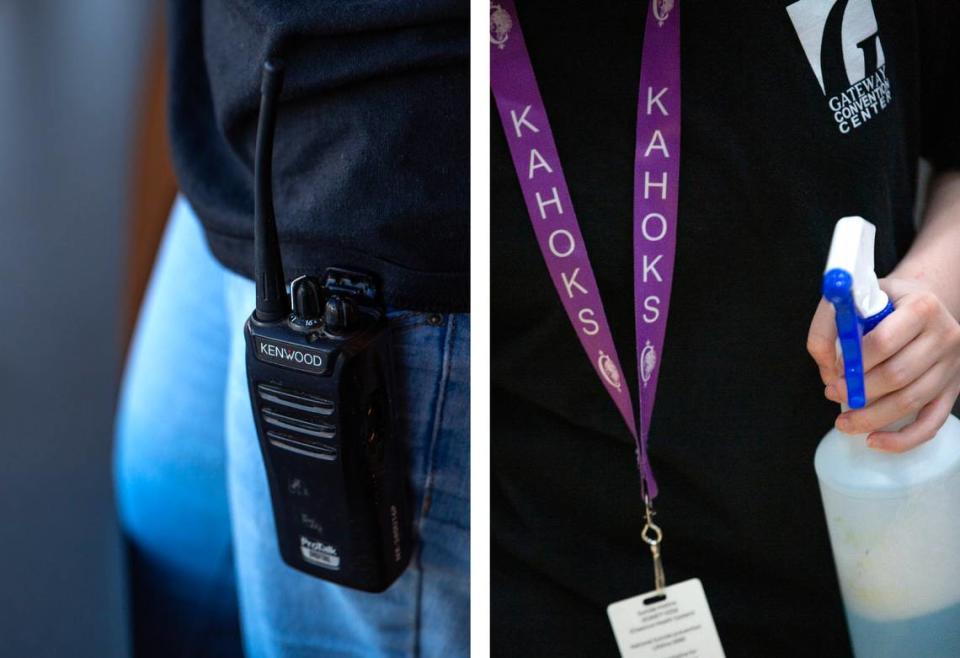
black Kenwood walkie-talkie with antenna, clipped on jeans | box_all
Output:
[244,60,412,592]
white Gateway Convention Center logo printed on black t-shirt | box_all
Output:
[787,0,893,134]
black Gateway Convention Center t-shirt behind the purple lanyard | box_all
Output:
[491,0,960,658]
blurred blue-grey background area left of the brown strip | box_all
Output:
[0,0,152,658]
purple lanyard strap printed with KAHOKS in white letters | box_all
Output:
[490,0,680,499]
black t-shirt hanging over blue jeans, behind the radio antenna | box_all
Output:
[170,0,469,311]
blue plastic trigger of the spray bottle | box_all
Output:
[823,269,893,409]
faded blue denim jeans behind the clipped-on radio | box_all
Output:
[115,199,470,658]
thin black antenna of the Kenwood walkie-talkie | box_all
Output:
[253,59,290,322]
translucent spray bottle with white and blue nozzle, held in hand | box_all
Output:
[814,217,960,658]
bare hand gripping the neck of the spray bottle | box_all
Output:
[807,278,960,452]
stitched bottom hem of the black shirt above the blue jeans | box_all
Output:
[204,227,470,313]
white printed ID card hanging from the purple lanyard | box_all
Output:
[607,578,724,658]
